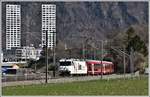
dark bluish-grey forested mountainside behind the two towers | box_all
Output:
[2,2,148,48]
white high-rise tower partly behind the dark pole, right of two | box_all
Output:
[42,4,56,49]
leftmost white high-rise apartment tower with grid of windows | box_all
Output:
[6,4,21,50]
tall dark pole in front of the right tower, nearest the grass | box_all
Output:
[45,31,48,83]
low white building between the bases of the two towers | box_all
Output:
[16,46,42,60]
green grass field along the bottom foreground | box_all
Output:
[2,77,148,96]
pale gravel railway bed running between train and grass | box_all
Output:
[2,74,138,87]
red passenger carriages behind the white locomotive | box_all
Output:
[86,60,114,75]
